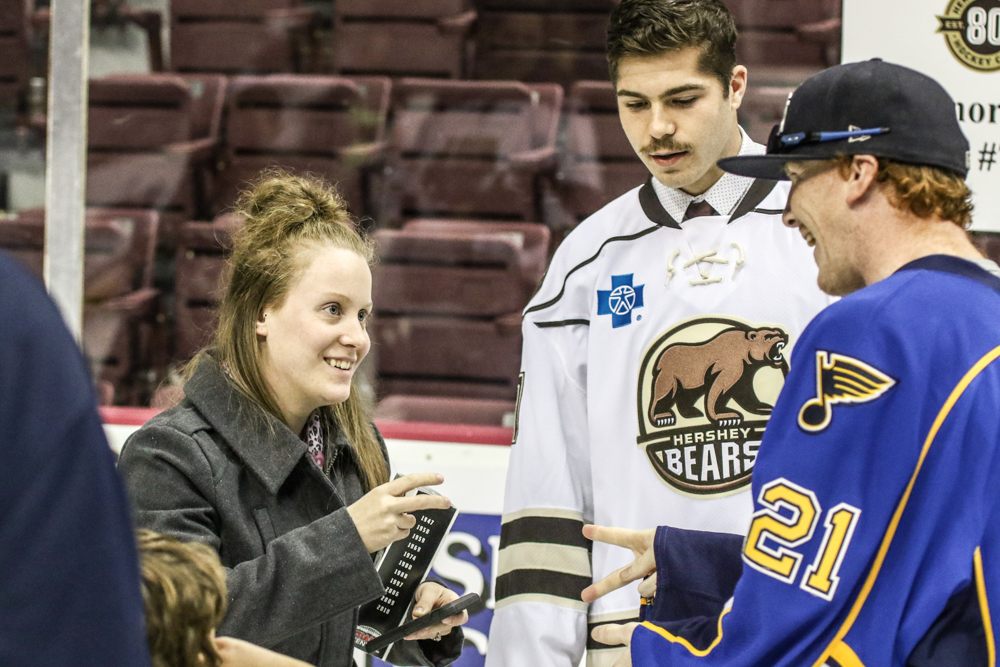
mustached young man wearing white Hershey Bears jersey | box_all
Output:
[486,0,829,667]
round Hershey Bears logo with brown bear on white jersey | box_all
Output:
[637,317,789,495]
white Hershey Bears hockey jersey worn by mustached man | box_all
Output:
[486,175,830,667]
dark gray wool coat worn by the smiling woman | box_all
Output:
[118,361,462,667]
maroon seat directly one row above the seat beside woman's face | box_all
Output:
[379,79,563,226]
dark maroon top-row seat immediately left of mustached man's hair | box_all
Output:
[474,0,614,87]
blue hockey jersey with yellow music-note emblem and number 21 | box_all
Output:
[632,255,1000,667]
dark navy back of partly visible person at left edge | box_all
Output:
[0,253,150,667]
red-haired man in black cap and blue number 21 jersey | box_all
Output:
[585,60,1000,667]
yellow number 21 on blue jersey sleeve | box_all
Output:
[743,478,861,600]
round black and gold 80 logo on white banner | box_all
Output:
[938,0,1000,72]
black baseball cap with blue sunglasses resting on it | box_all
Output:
[718,59,969,180]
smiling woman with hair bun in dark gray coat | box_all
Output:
[119,172,468,667]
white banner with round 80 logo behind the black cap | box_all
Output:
[843,0,1000,231]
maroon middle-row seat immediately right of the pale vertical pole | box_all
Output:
[87,74,226,247]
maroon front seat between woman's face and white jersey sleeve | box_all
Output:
[373,220,549,400]
